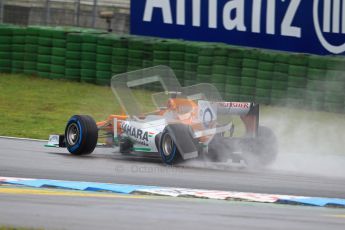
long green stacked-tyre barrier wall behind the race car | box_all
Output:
[0,25,345,112]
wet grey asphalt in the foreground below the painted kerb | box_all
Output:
[0,191,345,230]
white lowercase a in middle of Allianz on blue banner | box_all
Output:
[223,0,247,31]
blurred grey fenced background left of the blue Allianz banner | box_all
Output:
[0,0,130,33]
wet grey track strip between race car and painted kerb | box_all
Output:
[0,138,345,198]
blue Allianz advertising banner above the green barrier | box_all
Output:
[131,0,345,55]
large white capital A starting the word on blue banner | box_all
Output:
[143,0,173,24]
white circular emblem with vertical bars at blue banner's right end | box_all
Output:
[313,0,345,54]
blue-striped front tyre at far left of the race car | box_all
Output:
[65,115,98,155]
